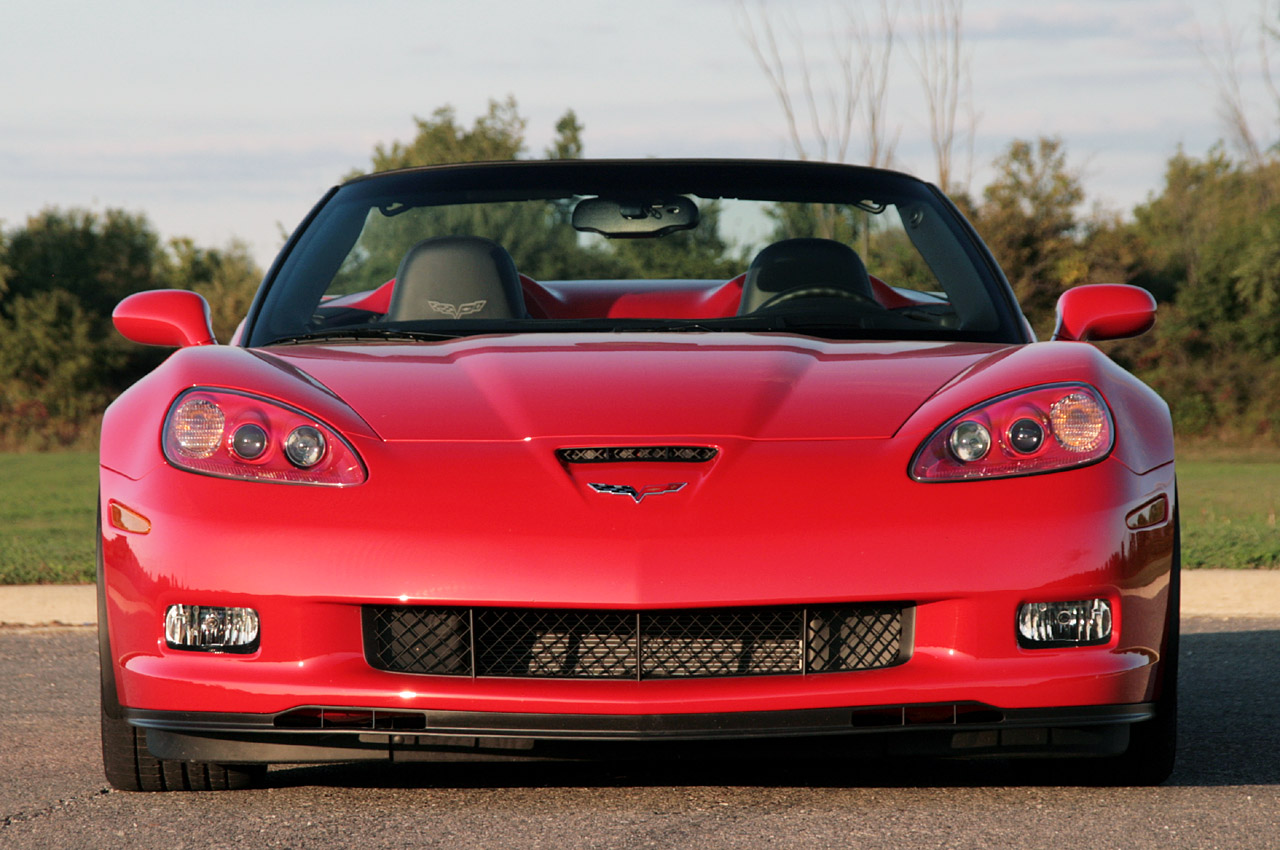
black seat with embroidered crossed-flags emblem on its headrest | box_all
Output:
[387,236,529,321]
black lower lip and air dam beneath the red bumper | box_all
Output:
[125,704,1155,764]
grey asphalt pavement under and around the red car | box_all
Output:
[0,617,1280,850]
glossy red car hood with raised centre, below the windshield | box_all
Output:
[255,333,1009,440]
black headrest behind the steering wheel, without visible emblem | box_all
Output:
[737,238,873,315]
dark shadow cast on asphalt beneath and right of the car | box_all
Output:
[266,621,1280,789]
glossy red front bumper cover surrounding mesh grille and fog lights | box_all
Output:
[101,435,1172,721]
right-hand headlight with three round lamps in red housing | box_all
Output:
[911,384,1115,481]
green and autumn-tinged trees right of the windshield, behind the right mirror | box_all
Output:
[969,140,1280,447]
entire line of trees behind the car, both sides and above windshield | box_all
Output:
[0,99,1280,449]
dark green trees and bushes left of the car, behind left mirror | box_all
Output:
[0,209,260,449]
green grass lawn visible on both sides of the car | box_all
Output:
[0,452,1280,584]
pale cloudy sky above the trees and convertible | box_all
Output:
[0,0,1280,269]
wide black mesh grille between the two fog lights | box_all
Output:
[364,605,908,680]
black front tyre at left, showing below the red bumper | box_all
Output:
[102,710,266,791]
